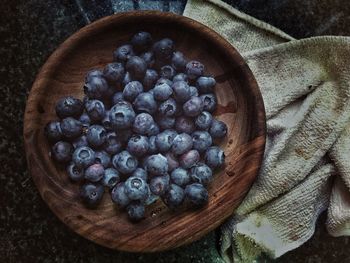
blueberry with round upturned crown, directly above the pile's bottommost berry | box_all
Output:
[125,176,149,200]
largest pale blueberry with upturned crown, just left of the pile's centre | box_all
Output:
[109,101,136,130]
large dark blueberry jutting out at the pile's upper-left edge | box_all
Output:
[55,96,84,119]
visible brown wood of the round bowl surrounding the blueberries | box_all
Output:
[24,11,265,252]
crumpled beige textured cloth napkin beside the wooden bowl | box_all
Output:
[184,0,350,262]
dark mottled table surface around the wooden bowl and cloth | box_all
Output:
[0,0,350,263]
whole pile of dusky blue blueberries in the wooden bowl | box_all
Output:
[45,32,227,221]
